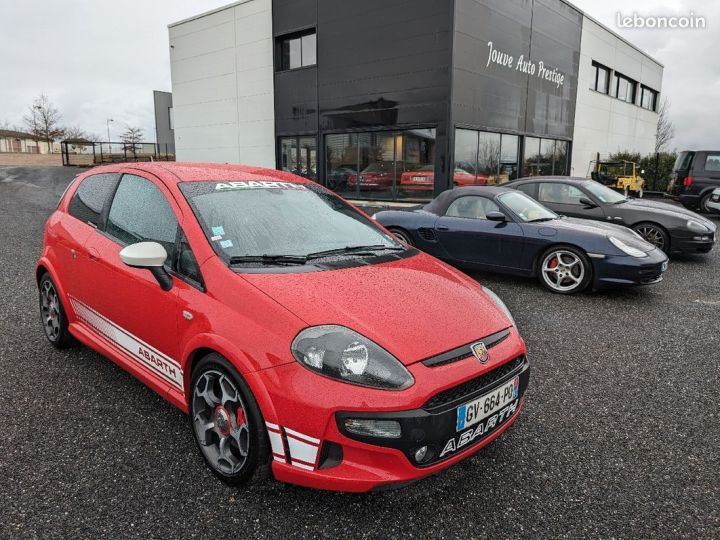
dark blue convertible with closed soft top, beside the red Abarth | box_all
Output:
[373,186,668,294]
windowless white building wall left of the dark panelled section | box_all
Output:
[169,0,275,168]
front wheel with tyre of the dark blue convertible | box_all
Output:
[539,246,592,294]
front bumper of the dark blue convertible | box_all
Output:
[593,249,668,289]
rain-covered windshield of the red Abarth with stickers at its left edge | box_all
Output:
[180,181,404,260]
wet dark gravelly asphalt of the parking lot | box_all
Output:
[0,168,720,538]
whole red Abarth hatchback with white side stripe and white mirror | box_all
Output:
[37,163,529,491]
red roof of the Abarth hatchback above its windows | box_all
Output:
[82,161,312,184]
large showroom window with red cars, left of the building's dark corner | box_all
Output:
[325,129,435,200]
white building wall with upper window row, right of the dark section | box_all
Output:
[572,17,663,176]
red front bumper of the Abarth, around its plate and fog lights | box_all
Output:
[251,328,530,492]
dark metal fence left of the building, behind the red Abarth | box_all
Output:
[60,141,175,167]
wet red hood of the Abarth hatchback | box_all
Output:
[242,253,511,365]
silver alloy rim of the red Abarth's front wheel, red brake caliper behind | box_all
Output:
[192,369,250,475]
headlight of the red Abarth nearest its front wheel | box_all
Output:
[290,325,415,390]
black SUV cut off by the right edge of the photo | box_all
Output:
[668,150,720,212]
